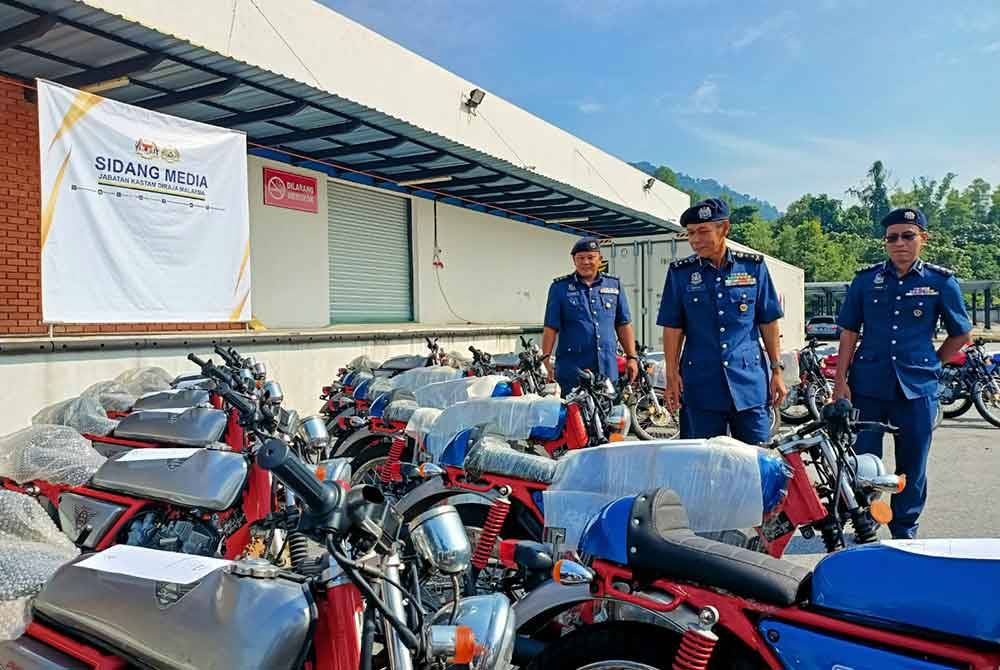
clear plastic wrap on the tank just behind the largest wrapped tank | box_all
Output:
[424,395,562,461]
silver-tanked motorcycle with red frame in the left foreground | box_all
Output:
[0,440,514,670]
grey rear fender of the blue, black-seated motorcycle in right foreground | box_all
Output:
[513,581,698,636]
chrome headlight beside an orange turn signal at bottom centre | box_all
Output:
[431,593,516,670]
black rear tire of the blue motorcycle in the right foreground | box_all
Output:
[528,622,681,670]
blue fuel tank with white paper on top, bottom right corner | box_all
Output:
[812,538,1000,644]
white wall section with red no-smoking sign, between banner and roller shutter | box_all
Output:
[247,156,330,328]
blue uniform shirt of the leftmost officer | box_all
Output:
[545,273,632,394]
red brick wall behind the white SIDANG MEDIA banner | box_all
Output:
[0,79,243,337]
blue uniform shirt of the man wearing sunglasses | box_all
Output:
[837,259,972,400]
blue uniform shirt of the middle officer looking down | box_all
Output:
[656,250,783,412]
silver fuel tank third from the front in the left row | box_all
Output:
[114,407,227,447]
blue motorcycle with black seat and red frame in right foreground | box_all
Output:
[514,489,1000,670]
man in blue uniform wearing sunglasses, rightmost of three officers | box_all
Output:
[834,207,972,538]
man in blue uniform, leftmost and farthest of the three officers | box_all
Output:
[542,237,639,396]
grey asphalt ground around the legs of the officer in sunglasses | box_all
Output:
[785,414,1000,567]
